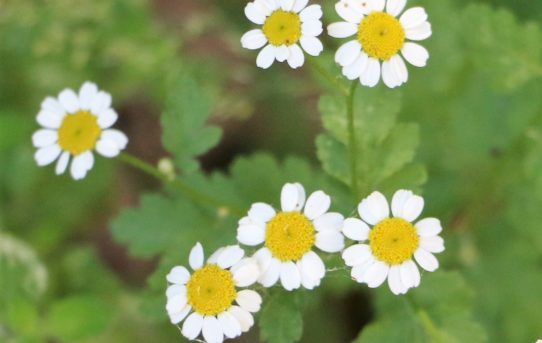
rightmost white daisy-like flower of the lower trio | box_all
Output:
[342,190,444,294]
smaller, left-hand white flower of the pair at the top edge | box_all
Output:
[241,0,323,69]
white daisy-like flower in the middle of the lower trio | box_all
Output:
[237,183,344,291]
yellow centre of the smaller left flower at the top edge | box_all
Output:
[263,10,301,46]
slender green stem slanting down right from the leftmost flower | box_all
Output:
[118,153,244,215]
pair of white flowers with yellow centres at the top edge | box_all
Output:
[241,0,432,88]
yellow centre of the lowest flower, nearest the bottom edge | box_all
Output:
[186,264,237,316]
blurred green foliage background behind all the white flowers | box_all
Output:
[0,0,542,343]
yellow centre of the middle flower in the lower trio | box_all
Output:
[265,212,315,262]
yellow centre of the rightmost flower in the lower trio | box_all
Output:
[369,218,420,265]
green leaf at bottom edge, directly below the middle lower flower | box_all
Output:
[259,292,303,343]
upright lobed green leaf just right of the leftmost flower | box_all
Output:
[161,75,222,172]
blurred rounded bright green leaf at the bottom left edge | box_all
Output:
[46,295,114,342]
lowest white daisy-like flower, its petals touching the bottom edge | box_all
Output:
[166,243,262,343]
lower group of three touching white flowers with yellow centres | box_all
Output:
[166,183,444,343]
